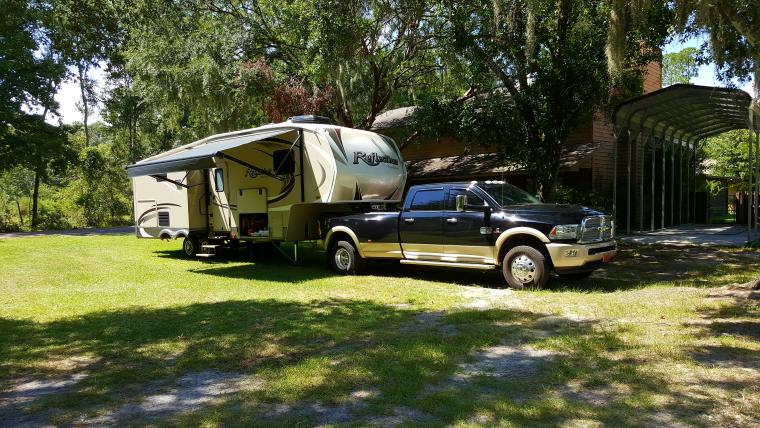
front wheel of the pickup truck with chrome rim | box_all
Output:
[501,245,549,289]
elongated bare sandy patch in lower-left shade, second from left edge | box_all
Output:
[82,371,254,425]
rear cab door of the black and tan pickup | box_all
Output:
[399,187,444,261]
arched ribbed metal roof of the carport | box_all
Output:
[614,84,760,142]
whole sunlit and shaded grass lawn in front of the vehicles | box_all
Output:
[0,236,760,426]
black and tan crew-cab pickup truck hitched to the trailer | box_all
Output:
[320,181,616,288]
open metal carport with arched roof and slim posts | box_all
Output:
[613,84,760,241]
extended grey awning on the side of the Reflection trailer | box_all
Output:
[127,129,293,178]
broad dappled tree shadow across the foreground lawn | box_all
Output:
[0,300,748,426]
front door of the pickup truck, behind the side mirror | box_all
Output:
[443,186,494,264]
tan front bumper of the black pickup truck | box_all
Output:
[546,241,617,272]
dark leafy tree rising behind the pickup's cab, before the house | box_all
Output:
[421,0,667,201]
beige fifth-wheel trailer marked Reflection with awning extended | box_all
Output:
[127,116,406,256]
